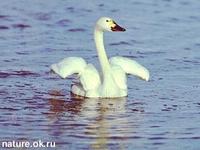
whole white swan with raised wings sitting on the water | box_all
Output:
[51,17,149,98]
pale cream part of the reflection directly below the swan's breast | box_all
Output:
[83,98,127,150]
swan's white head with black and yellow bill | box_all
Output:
[96,17,126,32]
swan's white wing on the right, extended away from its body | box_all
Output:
[110,56,149,81]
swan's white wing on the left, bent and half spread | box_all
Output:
[51,57,101,91]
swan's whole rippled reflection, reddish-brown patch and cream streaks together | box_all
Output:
[48,91,130,150]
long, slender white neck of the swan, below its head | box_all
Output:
[94,27,110,76]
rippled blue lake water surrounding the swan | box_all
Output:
[0,0,200,150]
